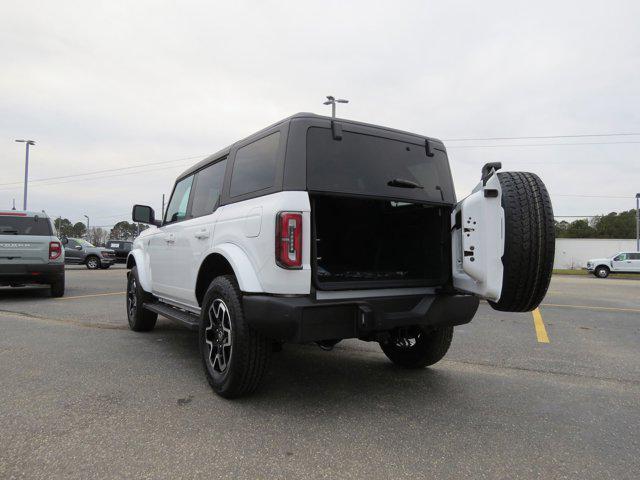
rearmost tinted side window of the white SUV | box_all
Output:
[230,132,280,197]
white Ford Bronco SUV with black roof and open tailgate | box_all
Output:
[126,113,555,397]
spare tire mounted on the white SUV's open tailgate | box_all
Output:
[489,172,555,312]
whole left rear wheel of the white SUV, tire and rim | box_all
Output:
[199,275,273,398]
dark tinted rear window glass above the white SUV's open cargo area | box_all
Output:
[307,127,455,203]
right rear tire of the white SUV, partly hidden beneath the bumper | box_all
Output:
[380,327,453,368]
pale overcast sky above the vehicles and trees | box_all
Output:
[0,0,640,225]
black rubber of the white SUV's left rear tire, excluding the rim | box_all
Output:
[199,275,273,398]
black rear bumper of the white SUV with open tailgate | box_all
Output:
[243,294,479,343]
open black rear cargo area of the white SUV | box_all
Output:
[311,194,450,290]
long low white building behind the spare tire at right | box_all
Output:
[553,238,636,269]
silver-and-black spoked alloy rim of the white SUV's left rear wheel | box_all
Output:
[204,298,232,373]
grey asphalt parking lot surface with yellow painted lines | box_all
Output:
[0,266,640,480]
